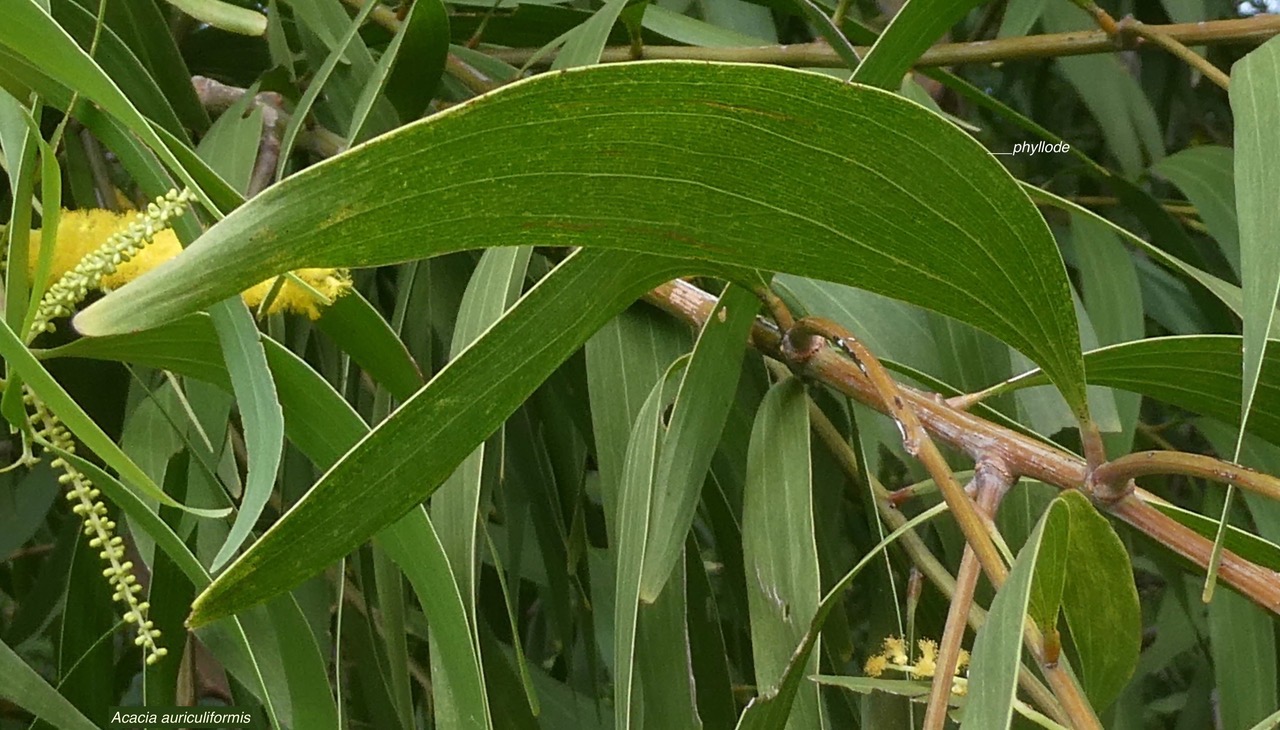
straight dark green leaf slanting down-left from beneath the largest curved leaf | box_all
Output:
[188,250,676,625]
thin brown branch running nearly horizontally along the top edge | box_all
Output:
[485,14,1280,68]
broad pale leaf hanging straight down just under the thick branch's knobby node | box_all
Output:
[742,378,826,729]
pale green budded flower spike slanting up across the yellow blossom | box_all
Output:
[27,190,196,341]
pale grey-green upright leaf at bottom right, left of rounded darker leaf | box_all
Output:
[960,491,1070,730]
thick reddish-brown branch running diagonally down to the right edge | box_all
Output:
[645,280,1280,613]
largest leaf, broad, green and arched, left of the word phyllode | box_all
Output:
[77,63,1087,416]
